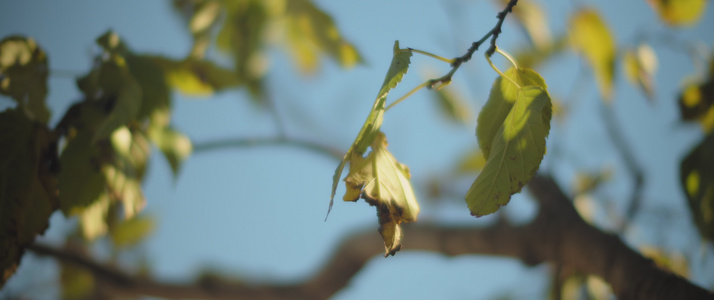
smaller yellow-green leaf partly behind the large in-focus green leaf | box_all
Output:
[476,68,546,159]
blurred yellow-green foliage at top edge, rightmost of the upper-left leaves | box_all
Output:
[285,0,362,73]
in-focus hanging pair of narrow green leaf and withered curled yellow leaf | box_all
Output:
[328,41,419,256]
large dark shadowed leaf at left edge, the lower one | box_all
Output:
[0,108,57,288]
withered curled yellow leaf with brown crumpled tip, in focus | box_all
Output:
[343,132,419,257]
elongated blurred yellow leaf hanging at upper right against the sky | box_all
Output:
[570,9,617,101]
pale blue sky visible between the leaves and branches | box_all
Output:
[0,0,714,299]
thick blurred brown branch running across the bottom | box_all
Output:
[28,176,714,299]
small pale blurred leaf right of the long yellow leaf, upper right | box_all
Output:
[623,44,657,101]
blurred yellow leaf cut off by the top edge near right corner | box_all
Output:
[647,0,707,26]
